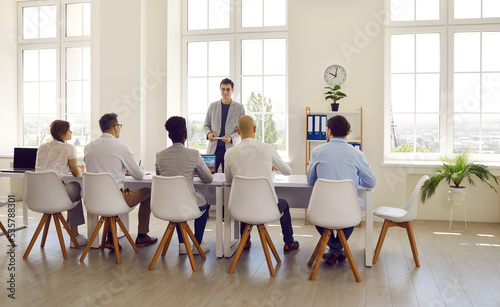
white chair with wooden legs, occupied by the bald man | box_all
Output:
[228,176,281,276]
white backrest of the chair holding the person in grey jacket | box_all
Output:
[151,176,203,222]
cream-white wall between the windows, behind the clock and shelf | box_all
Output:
[0,0,500,222]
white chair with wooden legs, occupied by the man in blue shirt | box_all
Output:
[307,179,361,282]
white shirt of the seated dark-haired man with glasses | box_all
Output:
[84,133,144,189]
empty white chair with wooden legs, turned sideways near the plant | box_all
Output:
[373,175,429,267]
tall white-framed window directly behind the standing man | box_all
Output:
[183,0,288,155]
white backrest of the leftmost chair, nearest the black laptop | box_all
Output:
[23,171,75,214]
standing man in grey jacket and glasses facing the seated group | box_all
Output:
[203,78,245,172]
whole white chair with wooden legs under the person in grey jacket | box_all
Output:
[149,176,206,272]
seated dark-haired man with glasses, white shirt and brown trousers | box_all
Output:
[84,113,158,249]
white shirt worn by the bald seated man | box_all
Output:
[224,138,292,203]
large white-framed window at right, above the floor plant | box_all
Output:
[385,0,500,161]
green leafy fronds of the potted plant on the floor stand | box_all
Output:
[420,148,498,202]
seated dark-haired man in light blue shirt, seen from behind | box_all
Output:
[307,115,375,265]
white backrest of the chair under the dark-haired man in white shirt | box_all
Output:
[83,172,133,216]
